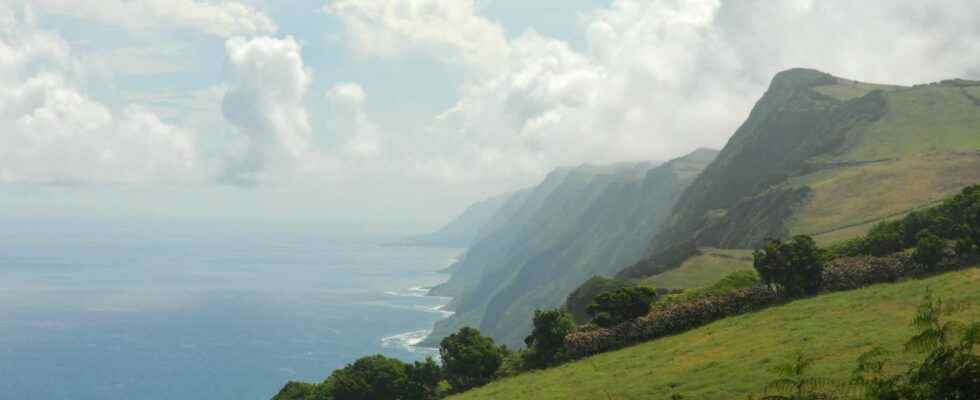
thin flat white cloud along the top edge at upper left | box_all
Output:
[31,0,278,38]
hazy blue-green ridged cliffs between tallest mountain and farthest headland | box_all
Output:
[429,150,716,346]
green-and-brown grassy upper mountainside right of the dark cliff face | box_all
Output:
[790,84,980,242]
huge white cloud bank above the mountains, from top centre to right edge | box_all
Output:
[326,0,980,181]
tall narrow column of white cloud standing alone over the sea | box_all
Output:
[222,37,313,182]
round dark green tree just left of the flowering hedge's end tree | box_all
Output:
[439,327,507,392]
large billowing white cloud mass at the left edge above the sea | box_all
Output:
[0,5,199,184]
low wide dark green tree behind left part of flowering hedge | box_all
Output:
[588,286,657,328]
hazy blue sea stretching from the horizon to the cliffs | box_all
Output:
[0,223,460,400]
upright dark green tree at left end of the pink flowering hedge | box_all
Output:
[524,310,575,368]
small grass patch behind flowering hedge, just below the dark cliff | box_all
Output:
[641,248,752,289]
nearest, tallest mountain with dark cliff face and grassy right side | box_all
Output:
[621,69,980,278]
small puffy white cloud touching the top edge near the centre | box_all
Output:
[324,0,510,69]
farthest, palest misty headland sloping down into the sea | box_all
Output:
[398,195,510,248]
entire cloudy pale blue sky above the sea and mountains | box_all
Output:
[0,0,980,231]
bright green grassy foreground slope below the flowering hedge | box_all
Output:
[453,268,980,400]
